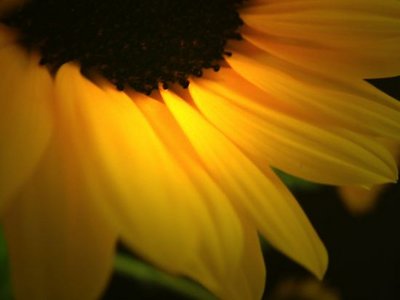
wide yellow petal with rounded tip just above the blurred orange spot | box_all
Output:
[190,80,397,185]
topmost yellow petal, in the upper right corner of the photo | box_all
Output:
[241,0,400,47]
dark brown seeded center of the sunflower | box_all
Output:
[1,0,245,93]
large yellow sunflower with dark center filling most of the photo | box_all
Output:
[0,0,400,300]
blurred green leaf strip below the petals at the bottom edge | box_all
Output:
[114,254,216,300]
